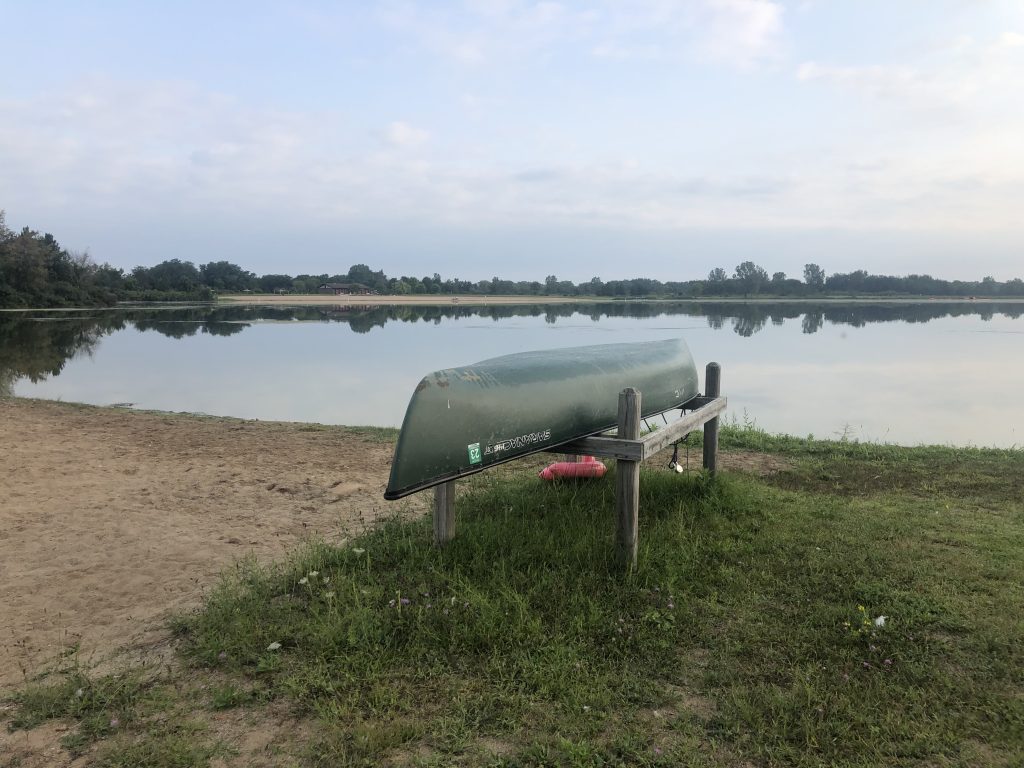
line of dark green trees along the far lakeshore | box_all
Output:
[0,211,1024,308]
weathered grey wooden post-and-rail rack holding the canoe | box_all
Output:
[434,362,727,569]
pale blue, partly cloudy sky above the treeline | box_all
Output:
[0,0,1024,282]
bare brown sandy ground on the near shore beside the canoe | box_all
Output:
[0,399,417,693]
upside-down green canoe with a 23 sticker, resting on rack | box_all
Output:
[384,339,697,499]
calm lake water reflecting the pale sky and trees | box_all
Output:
[0,302,1024,446]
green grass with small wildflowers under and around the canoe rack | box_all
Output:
[9,427,1024,767]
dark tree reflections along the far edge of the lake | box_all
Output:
[0,301,1024,396]
